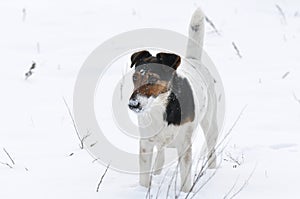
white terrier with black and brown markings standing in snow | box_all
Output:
[128,9,218,192]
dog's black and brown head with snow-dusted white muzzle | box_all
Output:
[128,51,181,113]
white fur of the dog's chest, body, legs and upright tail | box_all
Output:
[138,9,218,192]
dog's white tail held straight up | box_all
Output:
[186,8,205,60]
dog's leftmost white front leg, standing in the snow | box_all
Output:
[139,139,154,187]
